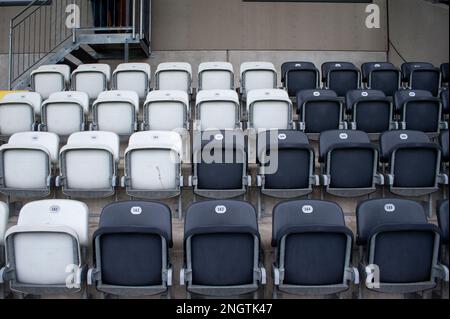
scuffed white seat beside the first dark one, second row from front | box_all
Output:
[122,131,183,214]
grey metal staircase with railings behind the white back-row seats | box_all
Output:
[8,0,151,90]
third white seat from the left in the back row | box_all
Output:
[112,63,152,100]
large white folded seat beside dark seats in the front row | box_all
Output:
[0,199,89,295]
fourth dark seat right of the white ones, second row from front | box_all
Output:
[380,131,448,200]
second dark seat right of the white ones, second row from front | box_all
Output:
[257,130,319,216]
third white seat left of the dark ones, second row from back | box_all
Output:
[144,90,190,131]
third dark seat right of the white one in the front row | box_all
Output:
[272,200,359,298]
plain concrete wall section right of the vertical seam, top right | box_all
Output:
[389,0,449,65]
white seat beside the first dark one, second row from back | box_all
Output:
[247,89,294,130]
